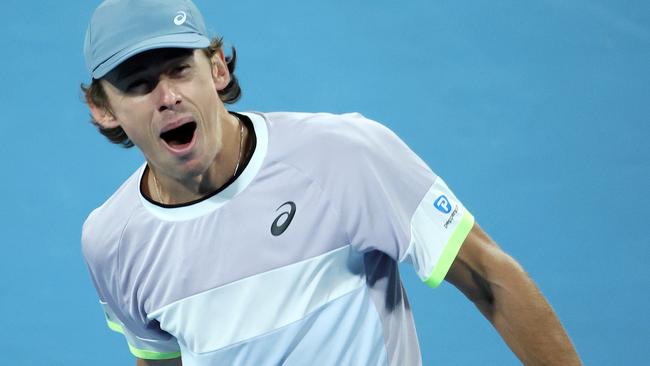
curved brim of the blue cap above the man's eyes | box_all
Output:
[93,33,210,79]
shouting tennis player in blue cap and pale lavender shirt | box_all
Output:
[82,0,580,366]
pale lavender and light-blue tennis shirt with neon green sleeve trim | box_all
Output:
[82,113,474,366]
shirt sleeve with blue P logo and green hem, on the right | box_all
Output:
[338,114,474,287]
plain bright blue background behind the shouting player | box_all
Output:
[0,0,650,365]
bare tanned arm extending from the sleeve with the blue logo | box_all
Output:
[445,224,581,366]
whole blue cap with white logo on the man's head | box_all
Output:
[84,0,210,79]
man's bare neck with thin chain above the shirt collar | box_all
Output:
[144,112,249,205]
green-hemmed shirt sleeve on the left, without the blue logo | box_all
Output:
[81,214,181,360]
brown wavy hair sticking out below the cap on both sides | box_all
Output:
[81,38,241,148]
